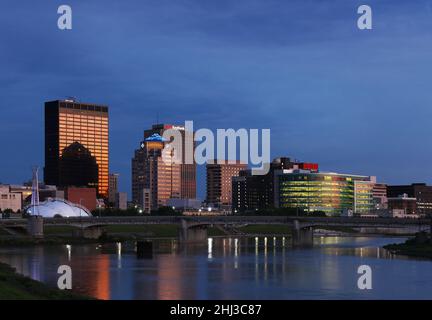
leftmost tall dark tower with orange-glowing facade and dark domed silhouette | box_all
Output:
[44,99,109,198]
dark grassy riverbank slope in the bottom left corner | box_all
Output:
[0,263,91,300]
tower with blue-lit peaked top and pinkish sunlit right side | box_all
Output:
[132,133,181,212]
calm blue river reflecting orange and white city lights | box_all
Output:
[0,237,432,300]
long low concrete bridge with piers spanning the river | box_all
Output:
[0,216,432,245]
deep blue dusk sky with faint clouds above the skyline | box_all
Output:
[0,0,432,198]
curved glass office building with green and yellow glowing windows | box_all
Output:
[275,170,375,216]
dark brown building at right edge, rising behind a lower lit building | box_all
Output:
[387,183,432,215]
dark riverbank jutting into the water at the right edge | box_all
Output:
[384,233,432,259]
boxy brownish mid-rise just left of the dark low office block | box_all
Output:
[206,160,247,206]
